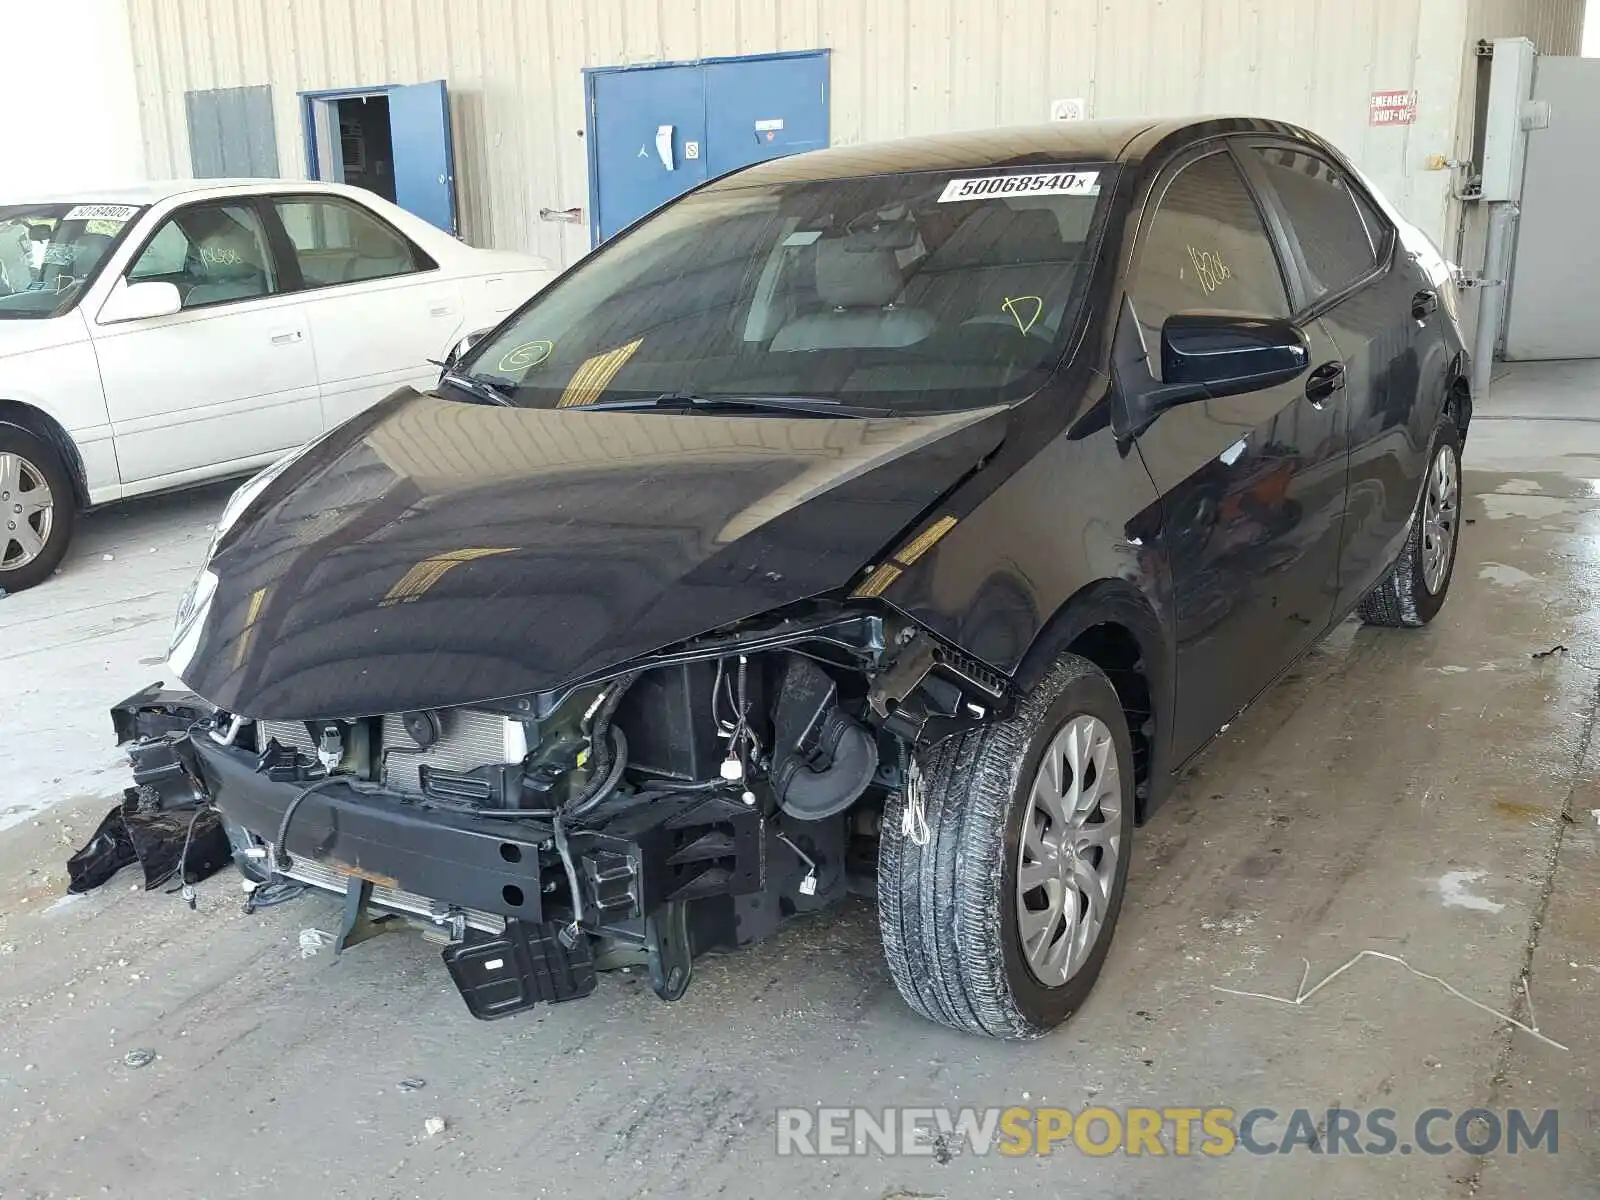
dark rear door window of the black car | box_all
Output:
[1245,146,1382,302]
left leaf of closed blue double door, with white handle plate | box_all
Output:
[589,66,706,242]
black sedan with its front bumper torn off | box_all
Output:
[114,118,1470,1038]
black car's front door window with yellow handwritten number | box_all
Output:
[1128,150,1290,365]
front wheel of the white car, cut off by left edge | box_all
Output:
[0,424,77,592]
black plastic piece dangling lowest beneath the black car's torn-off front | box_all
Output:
[445,920,595,1021]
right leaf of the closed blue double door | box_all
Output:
[704,51,827,178]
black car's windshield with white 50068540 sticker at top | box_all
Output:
[459,165,1114,413]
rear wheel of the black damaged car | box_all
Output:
[1357,413,1461,629]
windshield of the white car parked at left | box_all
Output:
[0,205,144,320]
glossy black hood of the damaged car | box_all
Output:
[179,389,1006,720]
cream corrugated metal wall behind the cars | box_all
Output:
[128,0,1581,262]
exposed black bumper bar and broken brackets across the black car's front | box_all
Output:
[112,690,771,1018]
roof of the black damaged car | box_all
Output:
[714,117,1318,187]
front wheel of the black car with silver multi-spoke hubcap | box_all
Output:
[878,654,1134,1038]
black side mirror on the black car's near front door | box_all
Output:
[1162,312,1310,403]
